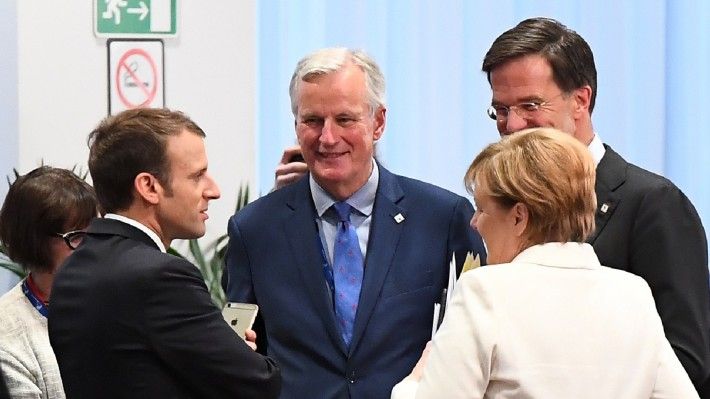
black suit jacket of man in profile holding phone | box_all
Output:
[49,219,281,398]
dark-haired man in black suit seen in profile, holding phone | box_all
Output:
[49,109,281,398]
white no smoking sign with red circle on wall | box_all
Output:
[108,40,165,115]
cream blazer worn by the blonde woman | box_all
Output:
[392,243,698,399]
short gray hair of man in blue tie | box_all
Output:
[288,47,385,116]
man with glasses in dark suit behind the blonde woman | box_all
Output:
[483,18,710,394]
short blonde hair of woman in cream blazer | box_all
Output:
[464,128,597,245]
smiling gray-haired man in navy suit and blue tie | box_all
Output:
[226,48,485,399]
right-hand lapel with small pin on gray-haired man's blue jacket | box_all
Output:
[350,166,407,353]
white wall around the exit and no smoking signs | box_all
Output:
[14,0,256,245]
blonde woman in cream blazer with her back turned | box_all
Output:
[392,128,698,399]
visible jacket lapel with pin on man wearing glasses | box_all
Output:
[587,144,628,244]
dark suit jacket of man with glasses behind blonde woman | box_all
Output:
[588,145,710,387]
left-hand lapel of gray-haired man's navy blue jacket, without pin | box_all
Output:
[283,177,347,354]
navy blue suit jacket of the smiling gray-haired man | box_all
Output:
[226,166,485,399]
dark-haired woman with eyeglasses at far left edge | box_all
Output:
[0,166,98,398]
